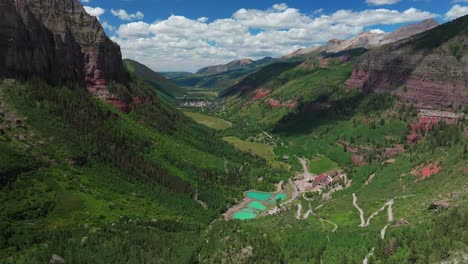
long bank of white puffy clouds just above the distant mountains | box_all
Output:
[113,4,437,70]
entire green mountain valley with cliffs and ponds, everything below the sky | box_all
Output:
[0,0,468,264]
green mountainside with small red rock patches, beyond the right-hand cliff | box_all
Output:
[215,50,364,134]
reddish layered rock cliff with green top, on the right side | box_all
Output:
[346,16,468,108]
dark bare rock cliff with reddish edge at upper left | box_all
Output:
[0,0,129,89]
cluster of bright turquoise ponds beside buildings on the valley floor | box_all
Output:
[233,191,288,220]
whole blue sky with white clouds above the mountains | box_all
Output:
[82,0,468,71]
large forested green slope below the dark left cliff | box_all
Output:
[0,74,288,263]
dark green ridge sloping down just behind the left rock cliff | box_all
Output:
[124,59,186,98]
